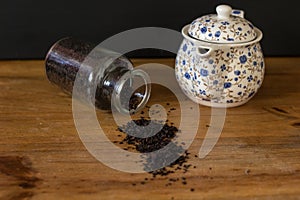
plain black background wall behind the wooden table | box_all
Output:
[0,0,300,59]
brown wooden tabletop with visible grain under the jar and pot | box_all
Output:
[0,58,300,199]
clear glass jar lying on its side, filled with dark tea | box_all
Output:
[45,38,151,113]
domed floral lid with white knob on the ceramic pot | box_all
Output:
[188,5,256,43]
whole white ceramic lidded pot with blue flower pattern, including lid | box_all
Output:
[175,5,265,107]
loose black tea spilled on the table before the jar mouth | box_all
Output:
[118,106,195,191]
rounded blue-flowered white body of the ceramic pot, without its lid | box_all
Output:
[175,25,265,107]
